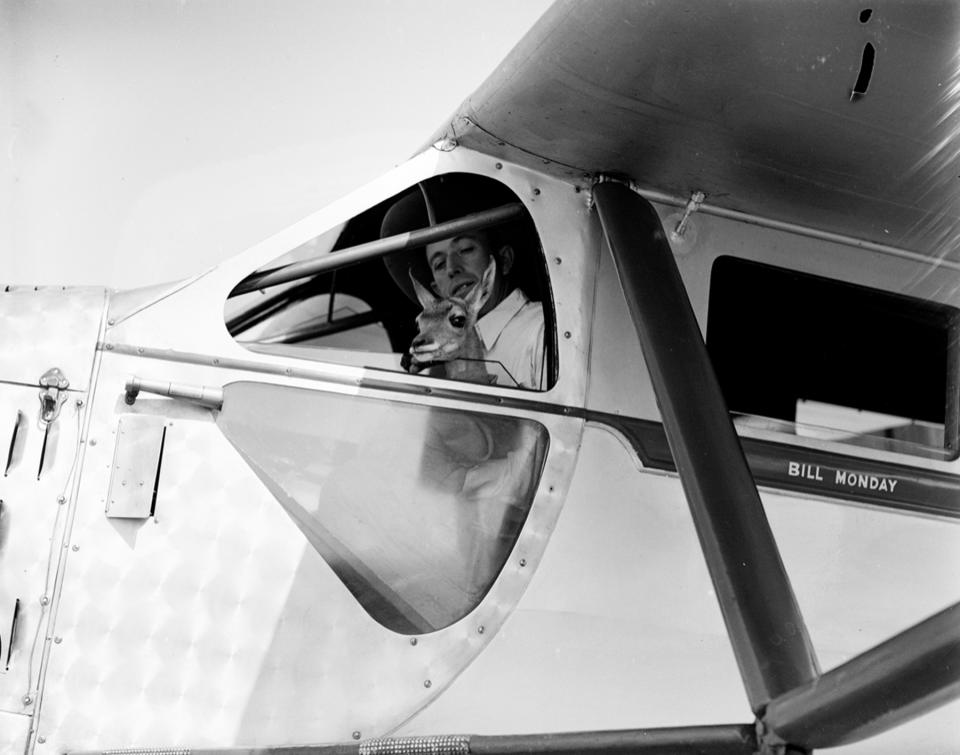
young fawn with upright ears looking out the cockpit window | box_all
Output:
[410,258,497,383]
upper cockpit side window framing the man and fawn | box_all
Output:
[225,174,555,390]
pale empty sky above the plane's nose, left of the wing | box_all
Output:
[0,0,550,288]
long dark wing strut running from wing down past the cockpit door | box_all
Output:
[594,182,819,716]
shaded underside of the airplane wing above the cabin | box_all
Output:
[438,0,960,264]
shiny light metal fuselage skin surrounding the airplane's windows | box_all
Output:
[0,147,960,753]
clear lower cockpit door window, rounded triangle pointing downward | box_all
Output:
[217,382,548,634]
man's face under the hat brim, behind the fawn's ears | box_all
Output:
[427,232,505,314]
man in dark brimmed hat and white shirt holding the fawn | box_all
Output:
[381,176,546,390]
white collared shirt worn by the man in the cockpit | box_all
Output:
[477,288,546,390]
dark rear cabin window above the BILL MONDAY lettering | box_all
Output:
[707,256,960,459]
